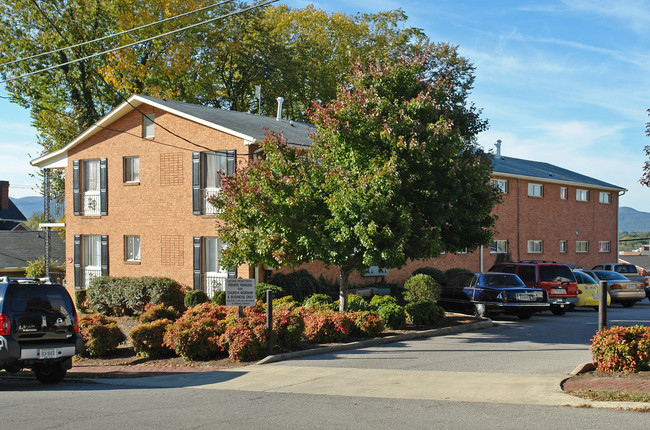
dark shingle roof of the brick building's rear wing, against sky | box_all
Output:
[493,156,625,191]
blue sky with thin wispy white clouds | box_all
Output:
[0,0,650,212]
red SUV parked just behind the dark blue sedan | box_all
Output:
[489,261,578,315]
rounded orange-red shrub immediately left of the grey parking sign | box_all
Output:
[164,302,235,360]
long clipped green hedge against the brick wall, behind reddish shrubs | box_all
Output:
[87,276,185,316]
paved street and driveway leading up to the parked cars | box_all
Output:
[0,302,650,429]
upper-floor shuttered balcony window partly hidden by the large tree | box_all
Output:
[192,150,237,215]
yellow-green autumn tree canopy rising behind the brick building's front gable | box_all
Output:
[0,0,427,197]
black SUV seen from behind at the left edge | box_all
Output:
[0,277,83,384]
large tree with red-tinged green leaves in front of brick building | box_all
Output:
[214,44,499,310]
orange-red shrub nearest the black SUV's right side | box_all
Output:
[79,314,126,357]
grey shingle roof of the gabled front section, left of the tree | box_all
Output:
[140,96,316,145]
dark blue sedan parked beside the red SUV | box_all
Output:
[438,272,549,319]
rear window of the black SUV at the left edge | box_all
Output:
[4,285,74,316]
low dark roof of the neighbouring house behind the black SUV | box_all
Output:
[0,231,65,269]
